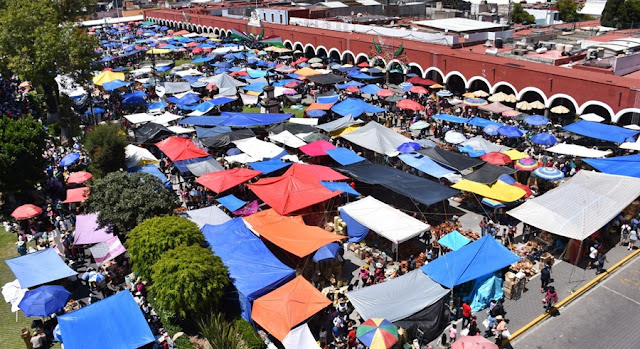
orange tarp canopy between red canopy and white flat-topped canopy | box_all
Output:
[244,209,346,258]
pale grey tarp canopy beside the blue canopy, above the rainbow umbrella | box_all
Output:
[347,270,448,322]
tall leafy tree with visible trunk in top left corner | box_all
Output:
[0,0,97,140]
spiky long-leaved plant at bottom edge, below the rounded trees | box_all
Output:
[198,313,247,349]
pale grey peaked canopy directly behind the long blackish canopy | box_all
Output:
[340,121,411,156]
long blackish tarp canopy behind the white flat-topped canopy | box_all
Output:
[337,161,459,205]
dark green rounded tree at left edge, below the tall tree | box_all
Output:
[0,116,47,193]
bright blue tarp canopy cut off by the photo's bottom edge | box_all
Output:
[58,290,155,349]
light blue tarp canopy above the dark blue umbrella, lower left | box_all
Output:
[5,248,78,288]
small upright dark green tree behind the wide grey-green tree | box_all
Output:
[84,124,128,177]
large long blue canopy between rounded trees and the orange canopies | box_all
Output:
[202,218,296,321]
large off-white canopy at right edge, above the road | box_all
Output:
[507,170,640,240]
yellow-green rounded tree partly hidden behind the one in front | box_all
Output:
[126,216,204,280]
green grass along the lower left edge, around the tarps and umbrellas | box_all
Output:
[0,227,60,349]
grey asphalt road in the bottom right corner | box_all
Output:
[512,253,640,349]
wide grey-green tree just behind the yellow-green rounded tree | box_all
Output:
[84,172,178,232]
